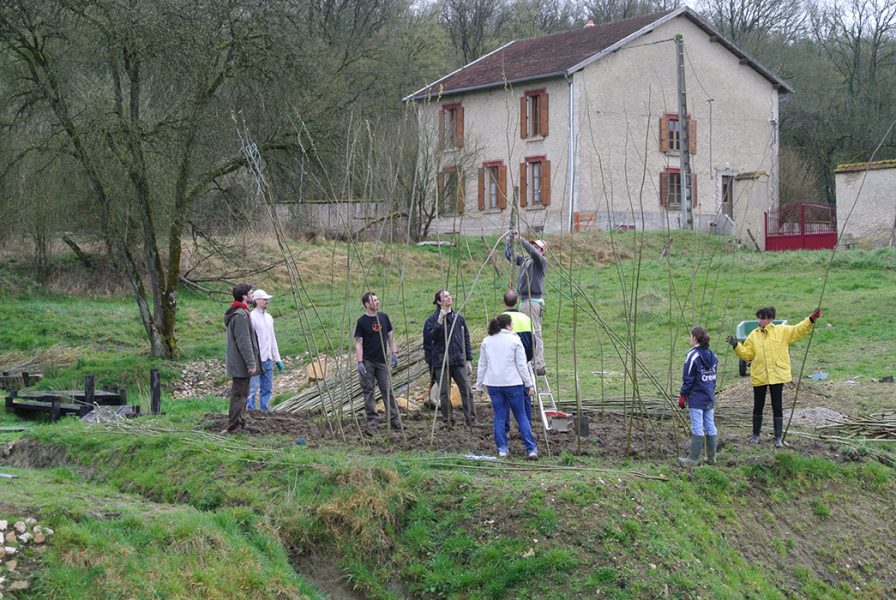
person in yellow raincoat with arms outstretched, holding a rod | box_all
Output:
[726,306,821,448]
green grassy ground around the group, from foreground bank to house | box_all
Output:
[0,234,896,599]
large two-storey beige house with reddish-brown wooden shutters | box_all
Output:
[405,7,792,241]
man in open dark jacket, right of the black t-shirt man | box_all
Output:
[423,290,476,425]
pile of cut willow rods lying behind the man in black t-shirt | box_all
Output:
[274,343,428,416]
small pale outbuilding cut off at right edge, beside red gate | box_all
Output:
[834,160,896,245]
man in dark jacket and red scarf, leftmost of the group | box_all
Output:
[221,283,261,433]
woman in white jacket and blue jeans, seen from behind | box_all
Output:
[476,314,538,460]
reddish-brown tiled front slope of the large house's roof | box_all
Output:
[413,10,673,98]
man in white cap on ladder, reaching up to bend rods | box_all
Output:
[504,231,548,376]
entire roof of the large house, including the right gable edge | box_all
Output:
[405,8,792,101]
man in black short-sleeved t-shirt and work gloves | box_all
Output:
[355,292,401,429]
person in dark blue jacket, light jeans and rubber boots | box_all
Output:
[678,327,719,467]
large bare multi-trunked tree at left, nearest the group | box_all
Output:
[0,0,304,358]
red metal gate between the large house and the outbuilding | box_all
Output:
[765,204,837,251]
